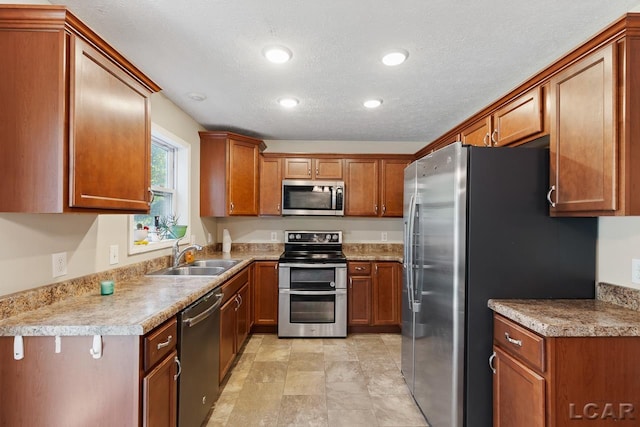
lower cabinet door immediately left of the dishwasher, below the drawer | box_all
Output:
[142,350,178,427]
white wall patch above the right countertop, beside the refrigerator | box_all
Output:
[597,216,640,289]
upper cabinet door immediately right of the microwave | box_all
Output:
[344,159,378,216]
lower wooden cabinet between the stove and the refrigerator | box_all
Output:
[347,261,402,327]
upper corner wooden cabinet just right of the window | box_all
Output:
[200,131,264,217]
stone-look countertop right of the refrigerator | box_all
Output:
[488,299,640,337]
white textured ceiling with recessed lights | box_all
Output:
[51,0,640,143]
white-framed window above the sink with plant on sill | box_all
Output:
[129,124,190,254]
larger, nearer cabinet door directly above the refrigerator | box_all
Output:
[492,86,542,147]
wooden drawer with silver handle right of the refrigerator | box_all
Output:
[493,315,545,372]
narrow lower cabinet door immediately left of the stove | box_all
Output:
[253,262,278,325]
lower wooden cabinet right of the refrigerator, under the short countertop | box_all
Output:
[491,314,640,427]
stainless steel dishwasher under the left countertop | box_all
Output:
[178,290,223,427]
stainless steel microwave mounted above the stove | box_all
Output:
[282,179,344,216]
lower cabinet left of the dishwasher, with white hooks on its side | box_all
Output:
[0,317,179,427]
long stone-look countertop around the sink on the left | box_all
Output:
[0,252,280,336]
